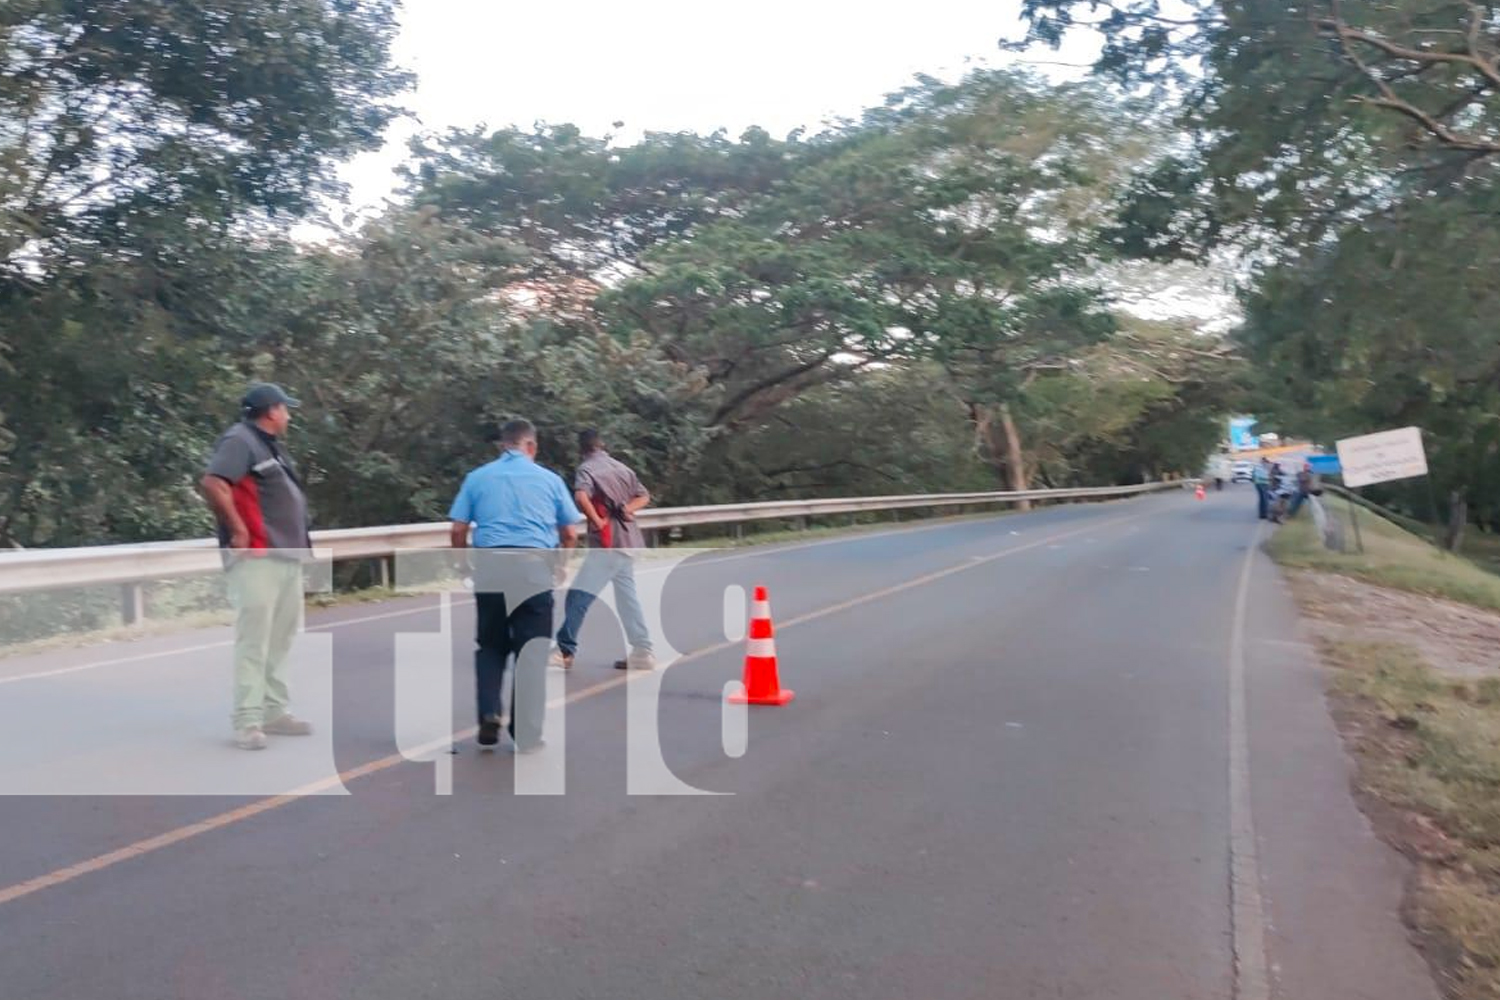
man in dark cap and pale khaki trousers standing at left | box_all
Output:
[200,384,312,750]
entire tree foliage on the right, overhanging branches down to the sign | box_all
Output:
[1013,0,1500,529]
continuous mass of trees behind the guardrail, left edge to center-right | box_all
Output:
[0,11,1236,546]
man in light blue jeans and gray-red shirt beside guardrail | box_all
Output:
[551,430,656,670]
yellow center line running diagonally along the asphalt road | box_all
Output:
[0,514,1149,906]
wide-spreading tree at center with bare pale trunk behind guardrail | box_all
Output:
[605,73,1152,487]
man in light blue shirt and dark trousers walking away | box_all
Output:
[449,420,584,754]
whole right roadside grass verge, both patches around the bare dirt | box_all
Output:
[1269,498,1500,1000]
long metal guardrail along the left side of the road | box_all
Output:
[0,481,1182,621]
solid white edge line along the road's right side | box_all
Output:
[1229,525,1271,1000]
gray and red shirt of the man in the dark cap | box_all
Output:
[207,421,312,558]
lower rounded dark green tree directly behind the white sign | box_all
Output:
[1242,187,1500,529]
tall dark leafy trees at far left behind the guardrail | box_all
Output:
[0,0,407,544]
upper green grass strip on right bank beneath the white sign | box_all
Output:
[1268,496,1500,610]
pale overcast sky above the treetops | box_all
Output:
[331,0,1104,220]
